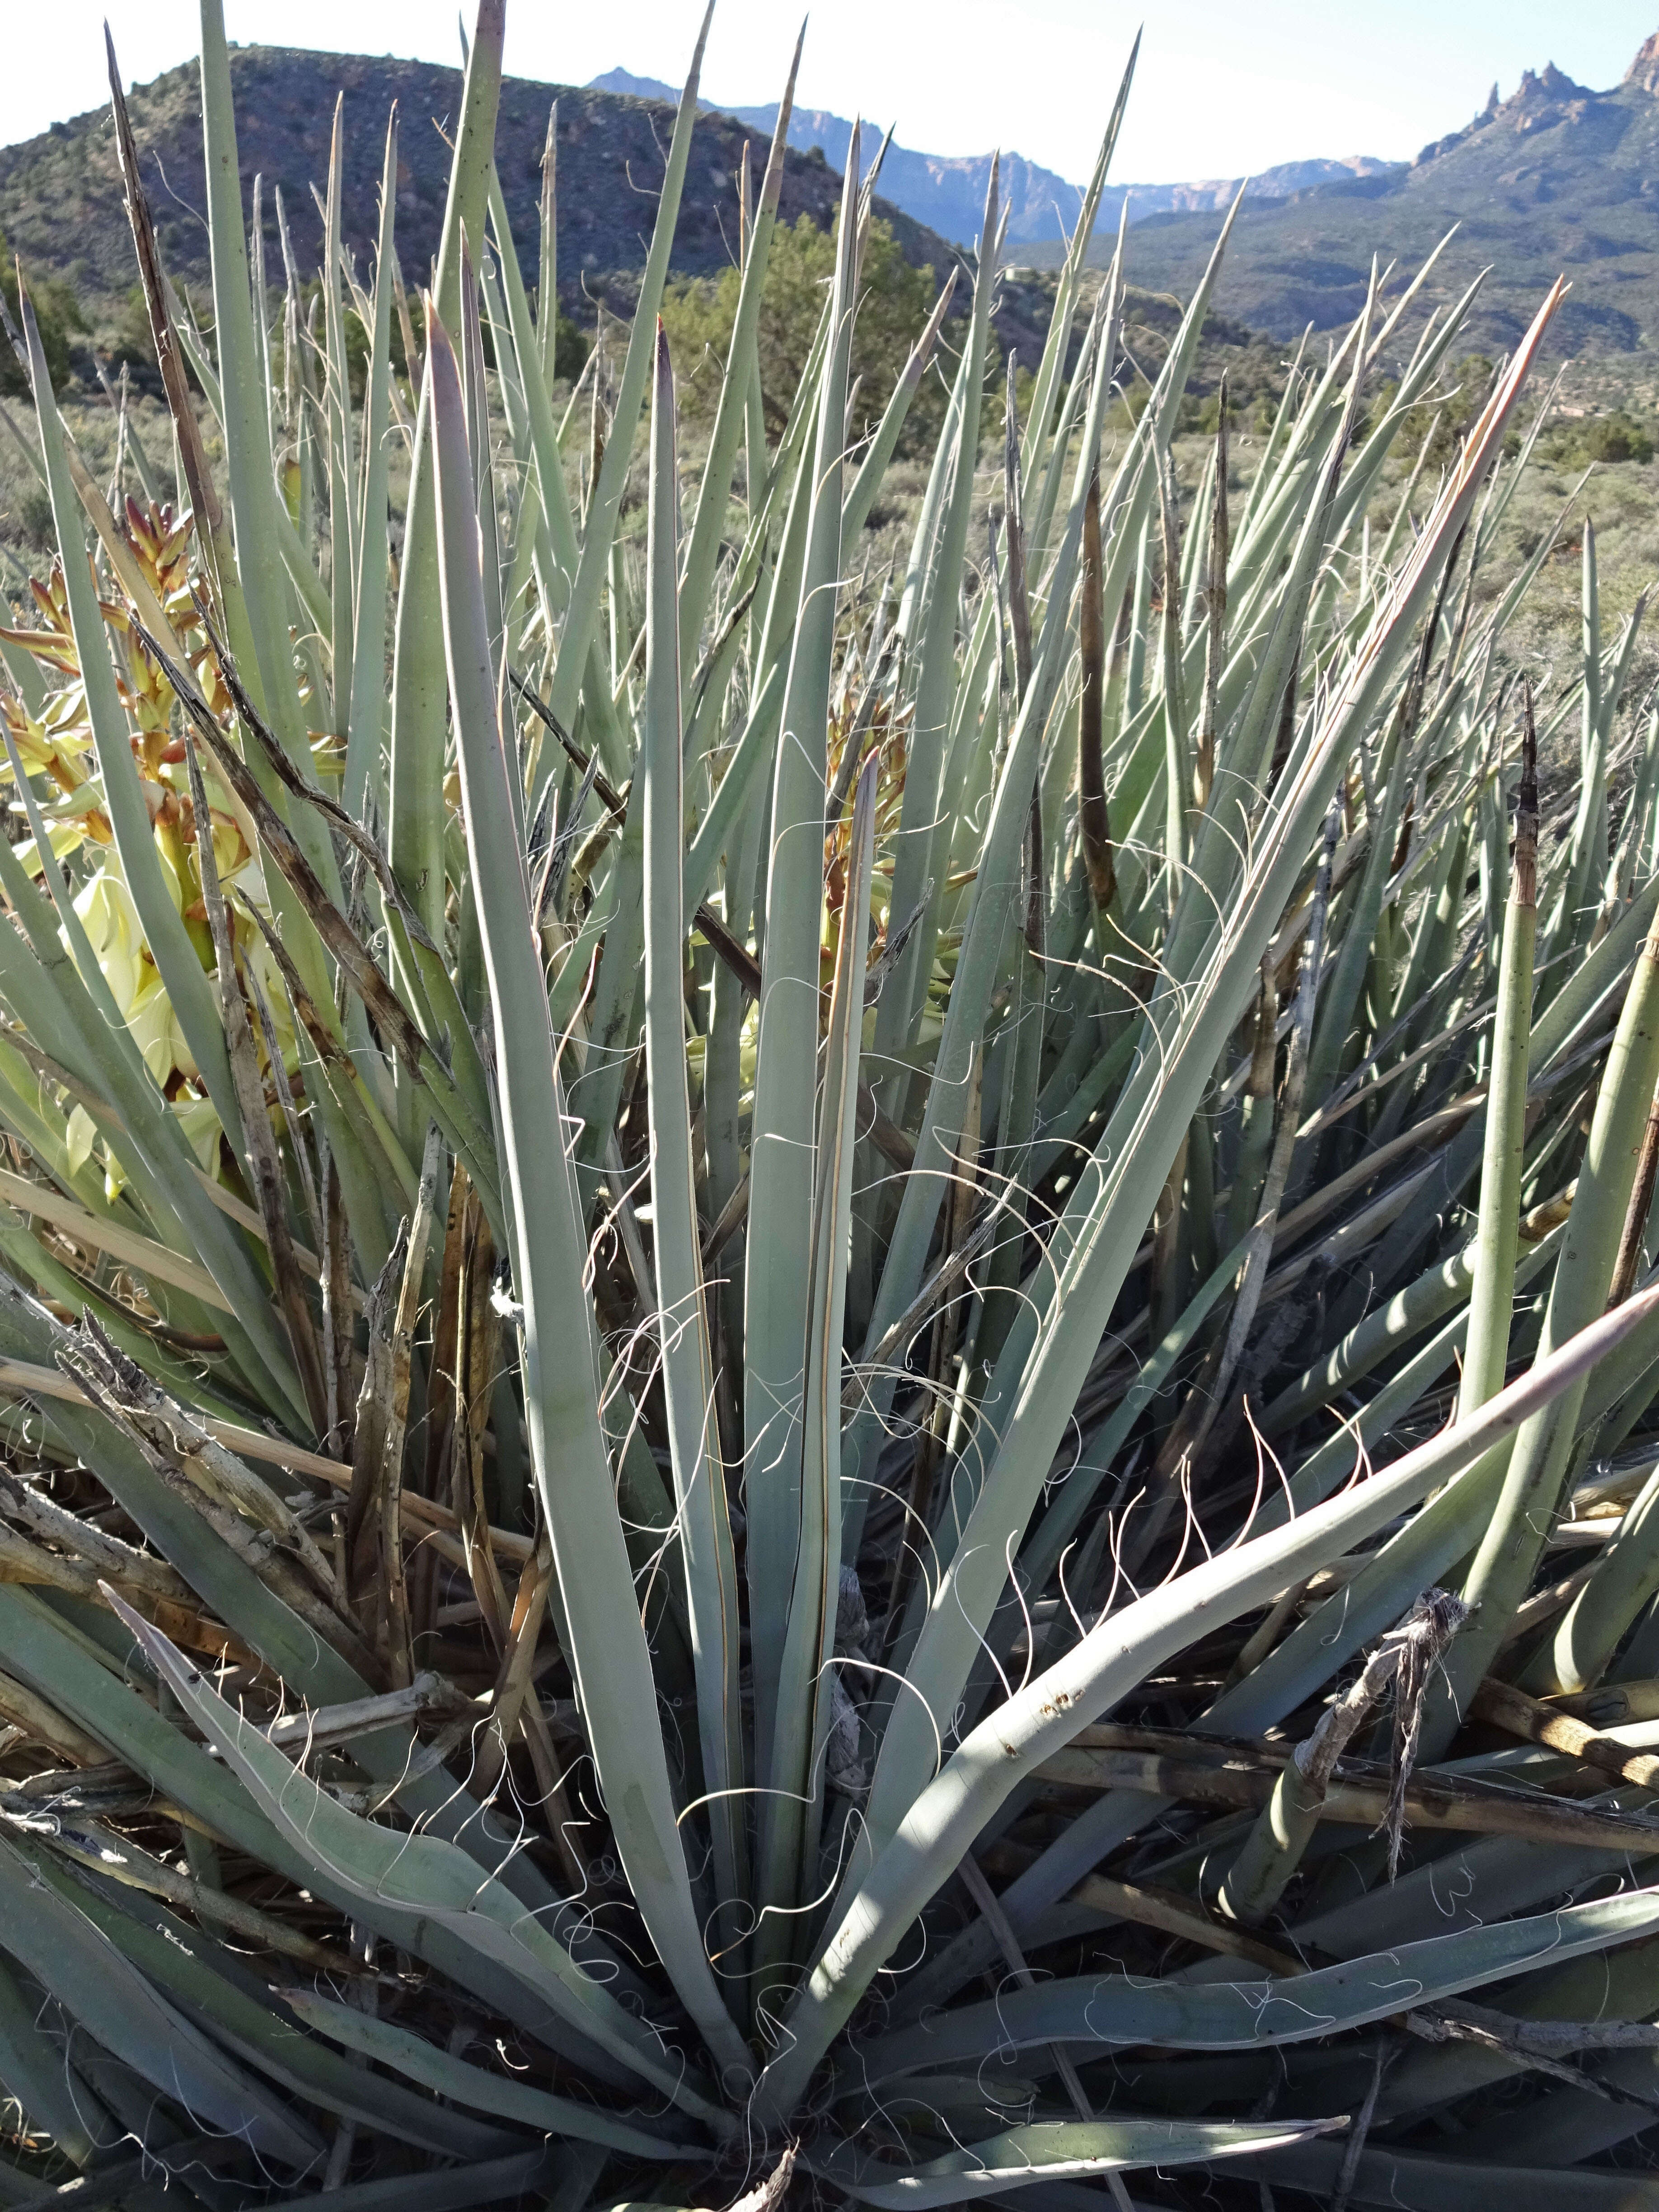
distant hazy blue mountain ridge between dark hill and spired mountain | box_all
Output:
[593,69,1402,245]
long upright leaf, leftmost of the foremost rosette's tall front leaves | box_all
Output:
[427,314,750,2073]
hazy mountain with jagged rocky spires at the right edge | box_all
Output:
[1029,33,1659,356]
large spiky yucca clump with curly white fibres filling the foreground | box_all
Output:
[0,0,1659,2212]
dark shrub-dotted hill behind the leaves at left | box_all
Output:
[0,47,956,340]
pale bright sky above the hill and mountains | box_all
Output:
[0,0,1659,183]
